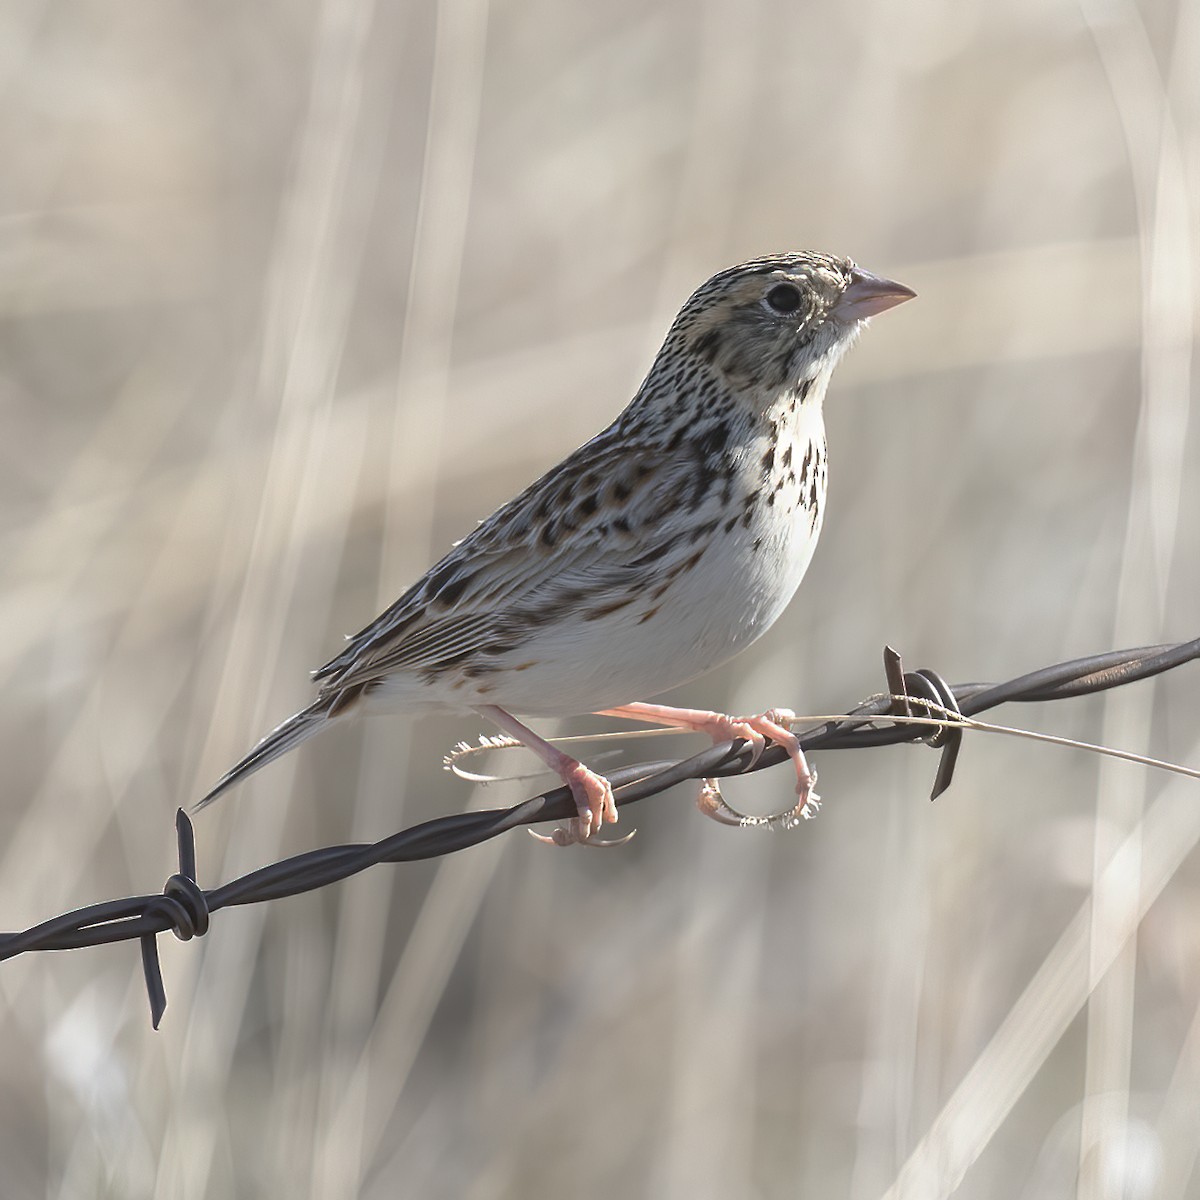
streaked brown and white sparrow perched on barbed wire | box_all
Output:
[196,251,916,845]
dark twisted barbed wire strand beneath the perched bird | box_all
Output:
[0,638,1200,1028]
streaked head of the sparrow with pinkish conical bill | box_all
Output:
[667,251,916,392]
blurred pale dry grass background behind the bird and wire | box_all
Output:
[0,0,1200,1200]
